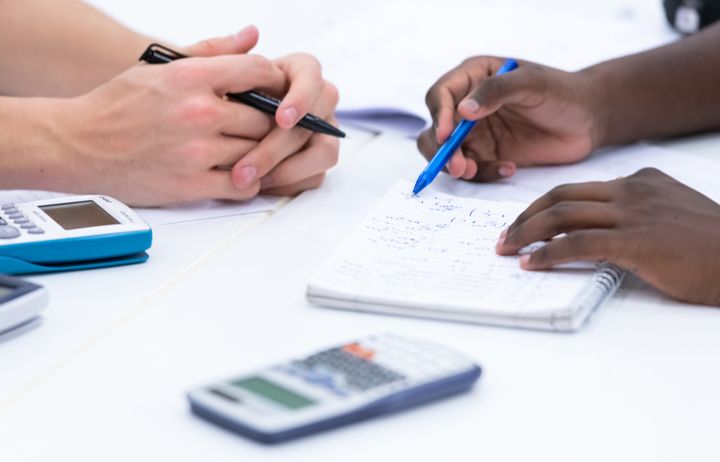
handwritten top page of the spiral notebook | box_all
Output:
[310,181,590,313]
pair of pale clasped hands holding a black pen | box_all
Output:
[60,27,338,206]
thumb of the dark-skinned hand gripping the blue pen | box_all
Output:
[458,68,533,120]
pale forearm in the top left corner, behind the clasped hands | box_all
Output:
[0,0,149,96]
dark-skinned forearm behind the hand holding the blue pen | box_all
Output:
[579,20,720,145]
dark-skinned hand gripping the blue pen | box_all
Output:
[418,56,600,181]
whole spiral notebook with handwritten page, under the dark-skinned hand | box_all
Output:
[307,181,624,331]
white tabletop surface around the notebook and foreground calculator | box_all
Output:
[0,2,720,461]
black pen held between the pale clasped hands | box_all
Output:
[140,43,345,138]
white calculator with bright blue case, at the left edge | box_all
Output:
[0,195,152,274]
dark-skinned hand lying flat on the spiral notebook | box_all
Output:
[496,168,720,305]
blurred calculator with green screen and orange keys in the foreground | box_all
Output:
[188,334,481,444]
